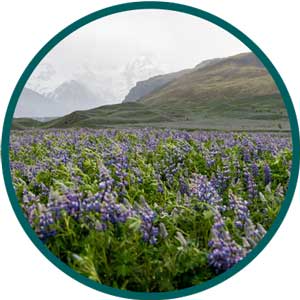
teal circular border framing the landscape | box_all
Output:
[1,1,300,299]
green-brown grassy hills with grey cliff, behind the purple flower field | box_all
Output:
[13,53,289,130]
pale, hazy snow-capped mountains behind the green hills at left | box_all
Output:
[15,55,164,117]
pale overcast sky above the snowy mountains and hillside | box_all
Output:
[42,10,249,72]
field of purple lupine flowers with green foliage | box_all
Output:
[10,129,292,292]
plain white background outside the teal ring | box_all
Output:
[0,0,300,300]
